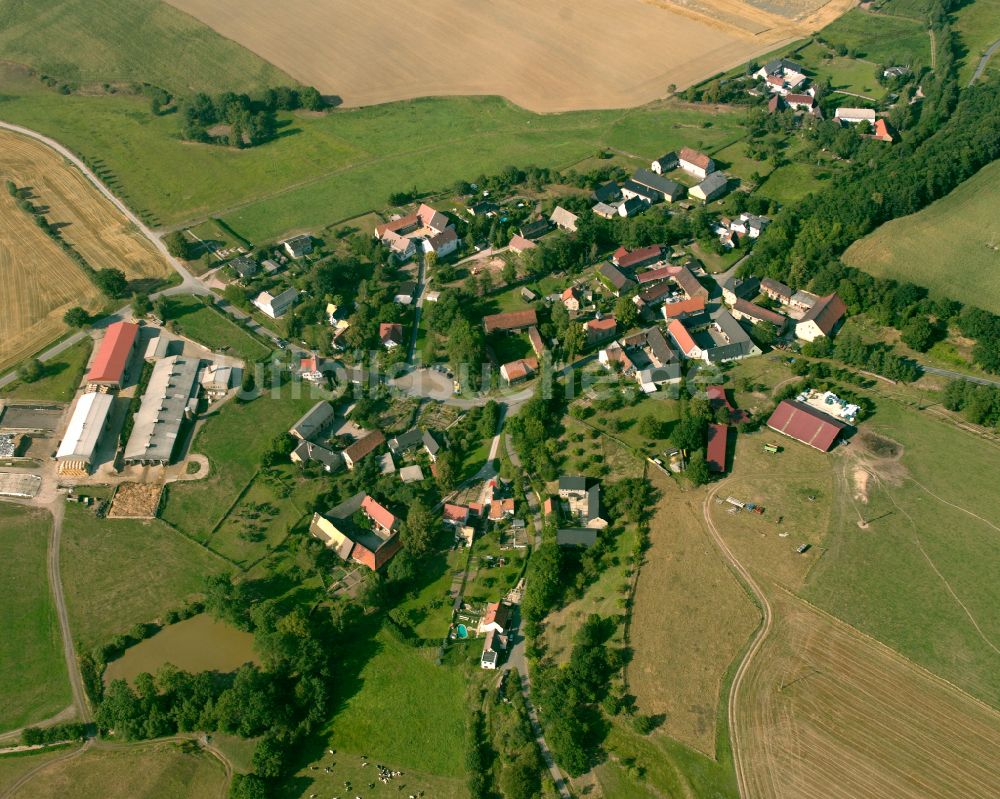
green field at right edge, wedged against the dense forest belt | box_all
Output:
[843,162,1000,313]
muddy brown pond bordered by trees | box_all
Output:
[104,613,260,682]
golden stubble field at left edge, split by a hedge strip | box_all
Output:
[0,130,169,368]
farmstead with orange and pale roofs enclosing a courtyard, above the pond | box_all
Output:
[309,492,401,571]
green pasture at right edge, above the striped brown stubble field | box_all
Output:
[803,401,1000,707]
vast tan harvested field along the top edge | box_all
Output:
[168,0,854,111]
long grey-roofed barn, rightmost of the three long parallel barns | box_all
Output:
[124,355,199,466]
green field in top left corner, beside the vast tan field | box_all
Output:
[0,0,296,93]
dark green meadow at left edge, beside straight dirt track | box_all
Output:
[0,504,72,732]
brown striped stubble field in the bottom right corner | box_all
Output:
[736,589,1000,799]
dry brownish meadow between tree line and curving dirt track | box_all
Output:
[628,469,759,757]
